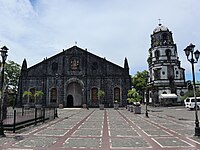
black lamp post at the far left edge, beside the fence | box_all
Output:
[0,46,8,137]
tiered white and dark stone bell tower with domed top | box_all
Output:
[148,24,187,104]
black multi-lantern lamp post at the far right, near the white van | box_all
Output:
[184,44,200,136]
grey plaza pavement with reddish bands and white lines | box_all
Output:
[0,106,200,150]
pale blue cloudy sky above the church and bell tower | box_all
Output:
[0,0,200,80]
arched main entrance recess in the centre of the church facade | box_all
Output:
[65,82,83,107]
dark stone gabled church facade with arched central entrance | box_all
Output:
[17,46,131,107]
